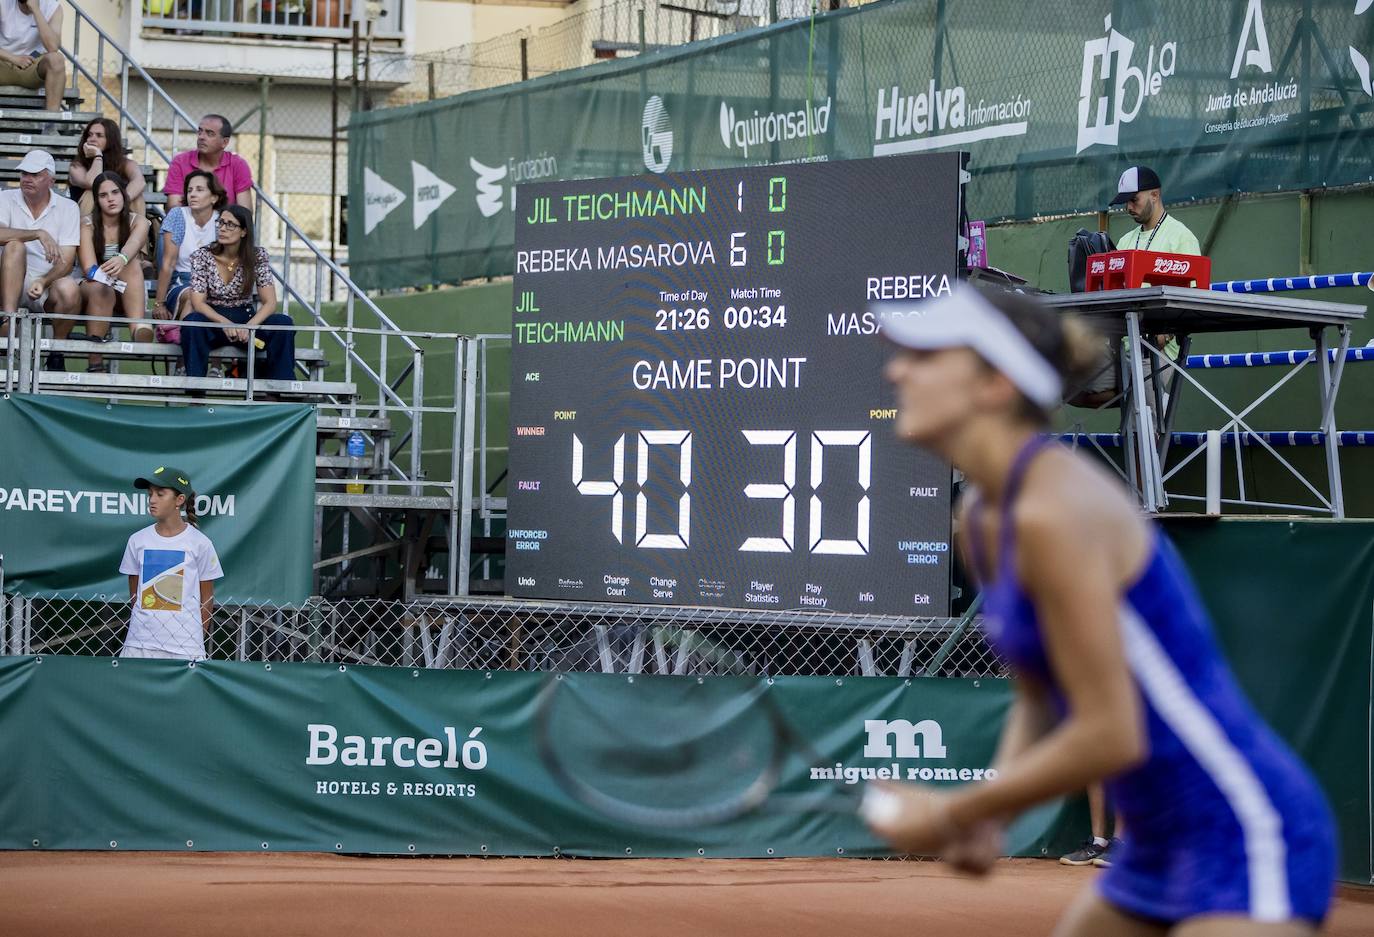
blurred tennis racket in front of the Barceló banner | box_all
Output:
[534,645,877,830]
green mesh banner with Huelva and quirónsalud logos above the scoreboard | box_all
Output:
[349,0,1374,289]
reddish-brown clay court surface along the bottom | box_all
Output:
[0,852,1374,937]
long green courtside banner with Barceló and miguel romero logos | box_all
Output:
[0,657,1085,856]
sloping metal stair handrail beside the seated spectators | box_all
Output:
[63,3,425,481]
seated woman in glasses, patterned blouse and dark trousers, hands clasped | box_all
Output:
[181,205,295,381]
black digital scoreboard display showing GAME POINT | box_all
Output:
[506,154,963,616]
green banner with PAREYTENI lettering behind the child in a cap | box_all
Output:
[0,394,315,605]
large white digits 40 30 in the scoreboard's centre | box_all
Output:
[573,430,872,556]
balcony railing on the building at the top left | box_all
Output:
[142,0,403,40]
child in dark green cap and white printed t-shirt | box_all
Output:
[120,466,224,661]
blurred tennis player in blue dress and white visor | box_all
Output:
[864,287,1336,937]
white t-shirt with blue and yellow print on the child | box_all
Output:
[120,525,224,661]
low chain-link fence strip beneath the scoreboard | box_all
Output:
[0,596,1006,677]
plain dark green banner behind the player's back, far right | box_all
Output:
[1165,518,1374,885]
